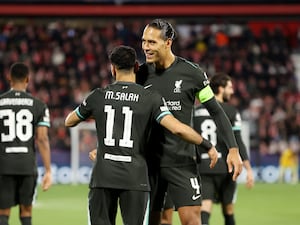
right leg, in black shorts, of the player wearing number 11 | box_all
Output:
[120,191,150,225]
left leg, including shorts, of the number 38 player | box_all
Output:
[0,175,17,225]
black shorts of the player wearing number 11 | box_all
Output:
[89,188,150,225]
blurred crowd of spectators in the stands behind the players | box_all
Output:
[0,18,300,163]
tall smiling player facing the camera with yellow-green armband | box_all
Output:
[137,19,242,225]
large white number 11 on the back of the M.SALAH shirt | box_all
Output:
[104,105,133,148]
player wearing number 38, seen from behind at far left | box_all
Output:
[0,62,52,225]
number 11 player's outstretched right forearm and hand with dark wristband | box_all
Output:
[160,114,218,168]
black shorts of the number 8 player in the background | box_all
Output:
[201,173,237,205]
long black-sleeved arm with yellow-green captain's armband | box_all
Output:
[197,85,243,180]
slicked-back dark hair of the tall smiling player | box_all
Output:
[148,19,176,40]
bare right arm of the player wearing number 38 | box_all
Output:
[36,126,52,191]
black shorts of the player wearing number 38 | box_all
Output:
[0,175,37,209]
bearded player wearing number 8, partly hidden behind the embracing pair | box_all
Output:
[194,73,254,225]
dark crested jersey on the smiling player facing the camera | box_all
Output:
[137,57,208,167]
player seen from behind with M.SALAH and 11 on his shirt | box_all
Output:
[65,46,217,225]
